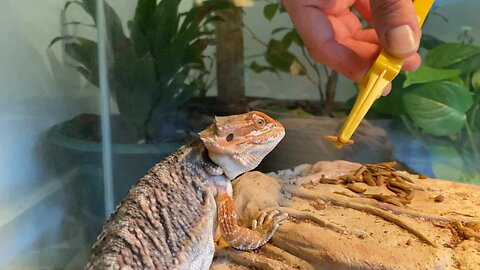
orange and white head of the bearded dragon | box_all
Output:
[200,111,285,179]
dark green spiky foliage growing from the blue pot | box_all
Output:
[50,0,228,142]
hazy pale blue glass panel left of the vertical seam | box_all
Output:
[0,1,104,269]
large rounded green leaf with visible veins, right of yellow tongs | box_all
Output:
[403,81,473,136]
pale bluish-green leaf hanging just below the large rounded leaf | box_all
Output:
[427,140,465,181]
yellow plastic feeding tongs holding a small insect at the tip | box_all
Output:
[325,0,434,148]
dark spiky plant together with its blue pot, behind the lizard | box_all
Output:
[39,0,228,229]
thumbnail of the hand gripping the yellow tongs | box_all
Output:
[385,25,417,55]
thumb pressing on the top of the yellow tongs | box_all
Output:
[370,0,422,58]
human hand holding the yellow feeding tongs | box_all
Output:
[282,0,421,94]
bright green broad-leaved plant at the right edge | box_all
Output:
[372,36,480,184]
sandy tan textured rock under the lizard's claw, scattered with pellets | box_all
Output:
[211,161,480,269]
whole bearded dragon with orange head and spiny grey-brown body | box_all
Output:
[85,111,287,269]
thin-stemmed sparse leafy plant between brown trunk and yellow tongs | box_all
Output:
[244,0,338,115]
